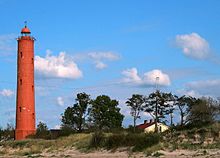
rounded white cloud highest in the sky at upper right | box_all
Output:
[175,33,211,60]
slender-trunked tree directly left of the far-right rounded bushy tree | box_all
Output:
[175,95,196,126]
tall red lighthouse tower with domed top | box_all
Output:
[15,24,36,140]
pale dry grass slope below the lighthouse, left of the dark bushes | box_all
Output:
[0,134,91,156]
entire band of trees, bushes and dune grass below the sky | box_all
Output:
[0,91,220,157]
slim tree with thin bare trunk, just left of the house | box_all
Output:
[126,94,144,132]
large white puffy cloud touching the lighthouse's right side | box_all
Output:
[34,50,82,79]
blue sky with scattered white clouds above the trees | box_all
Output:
[0,0,220,128]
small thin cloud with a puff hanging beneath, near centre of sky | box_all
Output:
[87,52,120,70]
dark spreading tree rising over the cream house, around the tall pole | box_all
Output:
[144,90,172,133]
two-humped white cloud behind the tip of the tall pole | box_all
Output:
[122,68,171,86]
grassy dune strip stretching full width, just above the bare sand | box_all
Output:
[0,124,220,157]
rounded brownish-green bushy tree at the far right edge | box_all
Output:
[187,97,220,126]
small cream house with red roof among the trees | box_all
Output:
[137,120,169,133]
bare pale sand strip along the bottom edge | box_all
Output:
[0,148,220,158]
